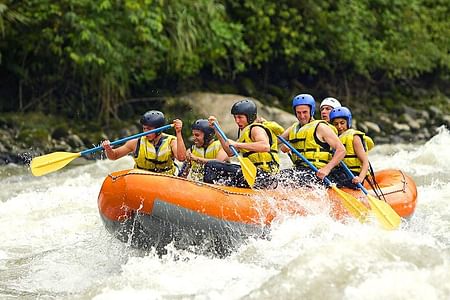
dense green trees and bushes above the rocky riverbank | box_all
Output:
[0,0,450,122]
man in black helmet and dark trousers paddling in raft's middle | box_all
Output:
[204,99,280,188]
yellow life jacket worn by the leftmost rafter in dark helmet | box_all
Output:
[134,133,177,175]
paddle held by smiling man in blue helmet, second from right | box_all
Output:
[278,135,369,222]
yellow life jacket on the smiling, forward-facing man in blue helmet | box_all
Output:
[289,120,333,169]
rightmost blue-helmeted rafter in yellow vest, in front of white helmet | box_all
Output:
[330,106,374,189]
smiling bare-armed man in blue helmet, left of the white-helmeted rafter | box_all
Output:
[281,94,345,185]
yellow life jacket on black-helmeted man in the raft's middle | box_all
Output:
[238,123,280,174]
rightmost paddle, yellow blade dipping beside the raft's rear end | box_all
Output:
[341,161,401,230]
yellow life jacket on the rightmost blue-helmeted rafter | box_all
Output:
[339,128,374,173]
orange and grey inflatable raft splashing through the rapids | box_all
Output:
[98,169,417,254]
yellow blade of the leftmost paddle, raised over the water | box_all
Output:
[30,152,81,176]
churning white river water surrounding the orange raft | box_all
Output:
[0,128,450,299]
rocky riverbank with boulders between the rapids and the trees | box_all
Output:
[0,93,450,165]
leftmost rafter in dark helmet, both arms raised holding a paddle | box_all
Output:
[102,110,186,175]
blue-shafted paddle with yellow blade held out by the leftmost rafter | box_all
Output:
[30,124,173,176]
